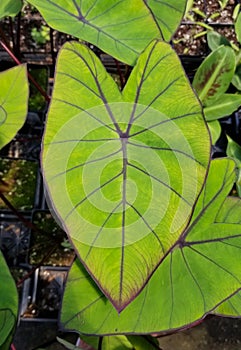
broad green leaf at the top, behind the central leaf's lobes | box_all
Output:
[26,0,186,65]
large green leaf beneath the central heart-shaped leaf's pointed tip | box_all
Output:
[61,158,241,334]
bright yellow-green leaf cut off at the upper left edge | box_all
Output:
[0,65,28,149]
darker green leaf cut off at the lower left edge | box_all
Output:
[0,252,18,350]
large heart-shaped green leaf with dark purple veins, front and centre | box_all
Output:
[43,41,210,311]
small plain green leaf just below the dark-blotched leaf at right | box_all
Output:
[203,94,241,121]
